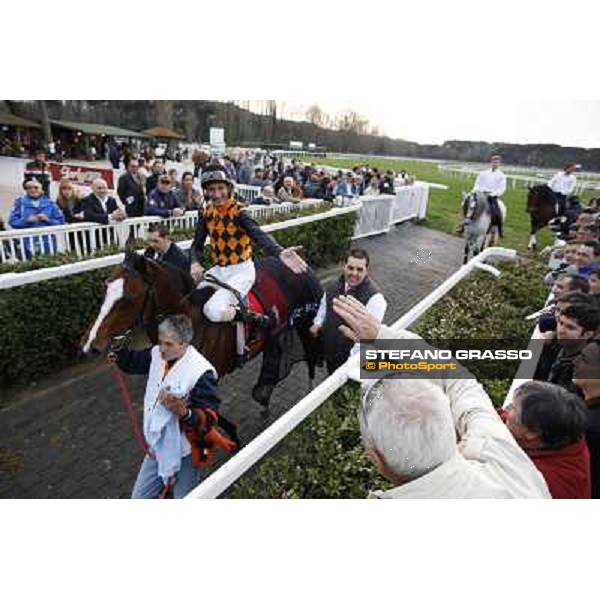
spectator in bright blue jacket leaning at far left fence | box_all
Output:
[8,179,65,258]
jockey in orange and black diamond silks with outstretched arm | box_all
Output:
[191,165,307,327]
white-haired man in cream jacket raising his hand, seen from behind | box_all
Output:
[334,297,551,499]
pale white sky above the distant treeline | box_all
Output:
[244,99,600,148]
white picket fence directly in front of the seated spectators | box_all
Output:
[0,199,325,263]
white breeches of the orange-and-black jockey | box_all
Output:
[198,260,256,323]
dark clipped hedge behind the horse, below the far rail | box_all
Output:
[0,211,357,386]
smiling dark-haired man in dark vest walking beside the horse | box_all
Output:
[310,248,387,375]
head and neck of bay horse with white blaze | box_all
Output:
[81,251,188,354]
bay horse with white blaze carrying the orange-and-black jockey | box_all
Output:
[81,249,323,407]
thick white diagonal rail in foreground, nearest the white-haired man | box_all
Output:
[186,248,516,499]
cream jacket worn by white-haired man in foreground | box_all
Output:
[369,326,551,499]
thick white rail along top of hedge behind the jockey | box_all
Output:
[0,204,361,290]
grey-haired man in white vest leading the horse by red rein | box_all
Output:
[115,315,232,499]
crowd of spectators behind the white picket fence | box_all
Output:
[3,146,413,250]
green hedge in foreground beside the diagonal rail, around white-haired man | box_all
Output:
[226,261,547,499]
